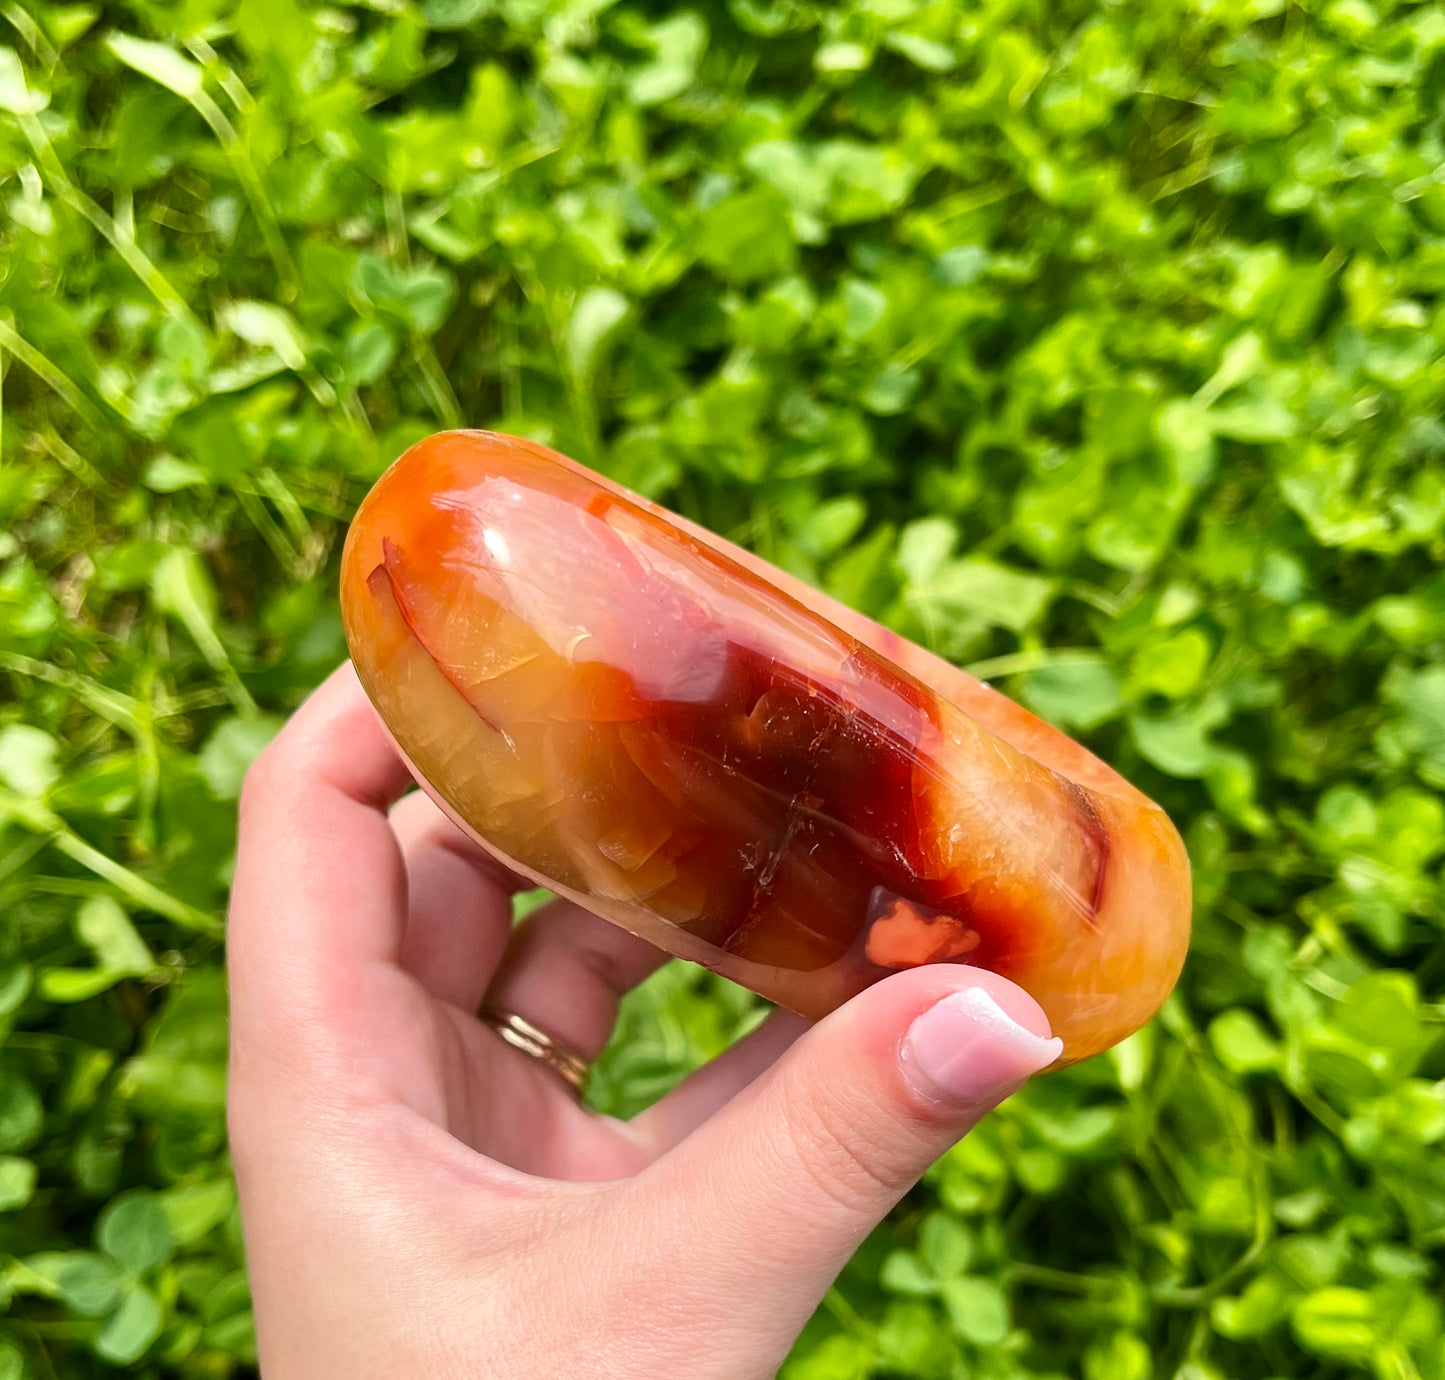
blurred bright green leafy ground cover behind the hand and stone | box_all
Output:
[0,0,1445,1380]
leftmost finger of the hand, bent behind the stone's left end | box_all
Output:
[227,663,410,1063]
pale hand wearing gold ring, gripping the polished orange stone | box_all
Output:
[228,666,1058,1380]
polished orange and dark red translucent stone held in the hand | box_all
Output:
[342,432,1189,1062]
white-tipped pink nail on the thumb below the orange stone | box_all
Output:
[903,987,1064,1104]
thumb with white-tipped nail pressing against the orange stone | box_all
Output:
[634,965,1064,1327]
